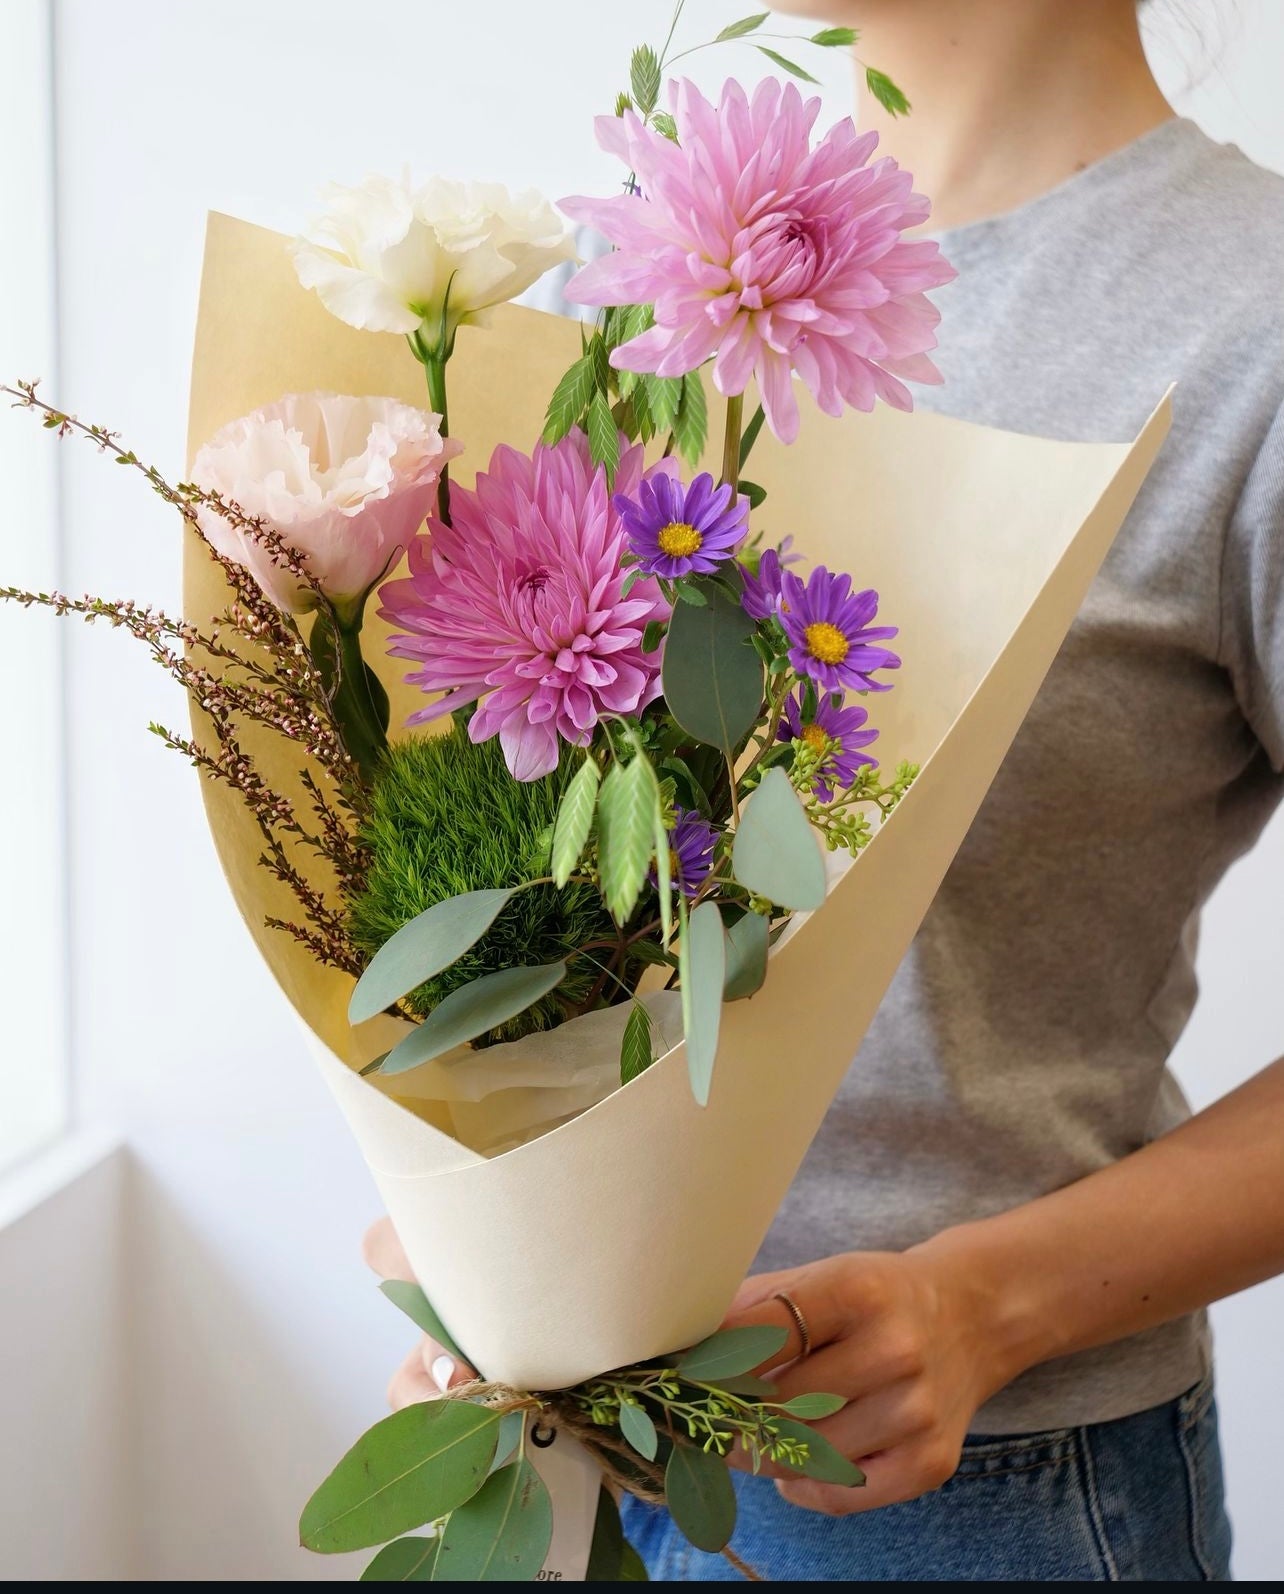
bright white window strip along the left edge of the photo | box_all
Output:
[0,0,72,1175]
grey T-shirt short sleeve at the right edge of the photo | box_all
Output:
[1222,410,1284,771]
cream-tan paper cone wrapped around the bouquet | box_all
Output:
[186,215,1169,1388]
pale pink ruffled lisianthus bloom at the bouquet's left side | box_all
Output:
[193,394,459,614]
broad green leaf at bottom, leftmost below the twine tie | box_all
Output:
[299,1400,499,1554]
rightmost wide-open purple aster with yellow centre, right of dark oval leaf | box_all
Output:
[781,564,900,692]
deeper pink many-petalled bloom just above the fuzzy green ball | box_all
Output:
[379,430,674,781]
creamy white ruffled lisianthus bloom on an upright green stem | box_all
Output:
[293,177,575,354]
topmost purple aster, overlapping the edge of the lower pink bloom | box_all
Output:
[615,470,749,580]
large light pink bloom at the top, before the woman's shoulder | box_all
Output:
[562,78,956,443]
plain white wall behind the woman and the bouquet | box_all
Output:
[5,0,1284,1580]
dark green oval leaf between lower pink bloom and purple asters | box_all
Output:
[661,582,763,757]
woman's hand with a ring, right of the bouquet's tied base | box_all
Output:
[725,1248,1018,1516]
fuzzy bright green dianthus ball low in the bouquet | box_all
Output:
[347,725,615,1044]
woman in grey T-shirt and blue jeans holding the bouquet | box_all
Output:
[370,0,1284,1581]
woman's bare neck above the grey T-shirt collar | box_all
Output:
[854,0,1172,230]
